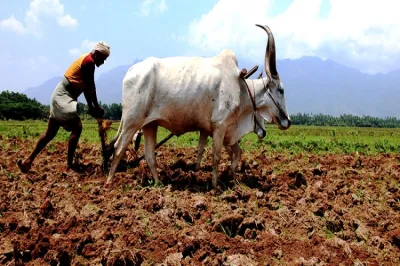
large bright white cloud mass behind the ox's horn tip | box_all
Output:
[188,0,400,73]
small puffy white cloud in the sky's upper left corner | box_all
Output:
[0,0,78,36]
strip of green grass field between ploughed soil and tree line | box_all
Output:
[0,120,400,154]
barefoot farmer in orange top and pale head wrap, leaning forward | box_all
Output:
[17,39,110,173]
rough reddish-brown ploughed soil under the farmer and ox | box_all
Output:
[0,138,400,265]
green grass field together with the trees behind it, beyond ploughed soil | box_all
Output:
[0,91,400,154]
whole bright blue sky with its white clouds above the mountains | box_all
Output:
[0,0,400,91]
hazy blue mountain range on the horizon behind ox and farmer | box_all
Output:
[25,57,400,117]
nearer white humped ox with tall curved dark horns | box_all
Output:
[107,25,290,187]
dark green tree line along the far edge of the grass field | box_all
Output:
[0,91,400,128]
